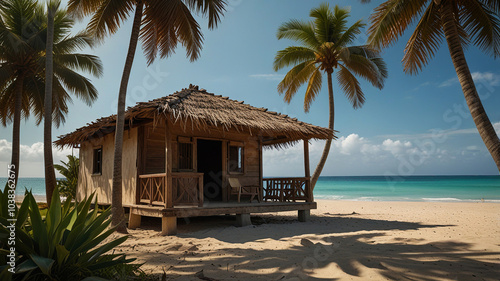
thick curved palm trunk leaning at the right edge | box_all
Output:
[440,1,500,172]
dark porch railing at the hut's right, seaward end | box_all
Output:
[262,177,313,202]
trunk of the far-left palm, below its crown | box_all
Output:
[8,75,24,190]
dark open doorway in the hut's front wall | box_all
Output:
[197,139,222,201]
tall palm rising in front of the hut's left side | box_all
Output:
[68,0,226,233]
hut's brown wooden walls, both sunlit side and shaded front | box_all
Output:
[77,117,261,205]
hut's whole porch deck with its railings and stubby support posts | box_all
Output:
[126,173,317,235]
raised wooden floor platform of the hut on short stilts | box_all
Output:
[126,202,317,235]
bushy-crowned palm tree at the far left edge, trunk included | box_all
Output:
[0,0,102,192]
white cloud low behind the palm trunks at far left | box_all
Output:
[0,139,78,177]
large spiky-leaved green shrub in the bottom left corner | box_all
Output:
[0,187,140,281]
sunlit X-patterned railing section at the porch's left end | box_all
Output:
[139,173,166,205]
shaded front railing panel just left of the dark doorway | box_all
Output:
[172,173,203,207]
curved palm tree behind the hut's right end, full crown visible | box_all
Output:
[274,3,387,188]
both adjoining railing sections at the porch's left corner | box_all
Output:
[138,173,203,207]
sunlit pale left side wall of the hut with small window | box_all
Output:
[77,128,138,204]
